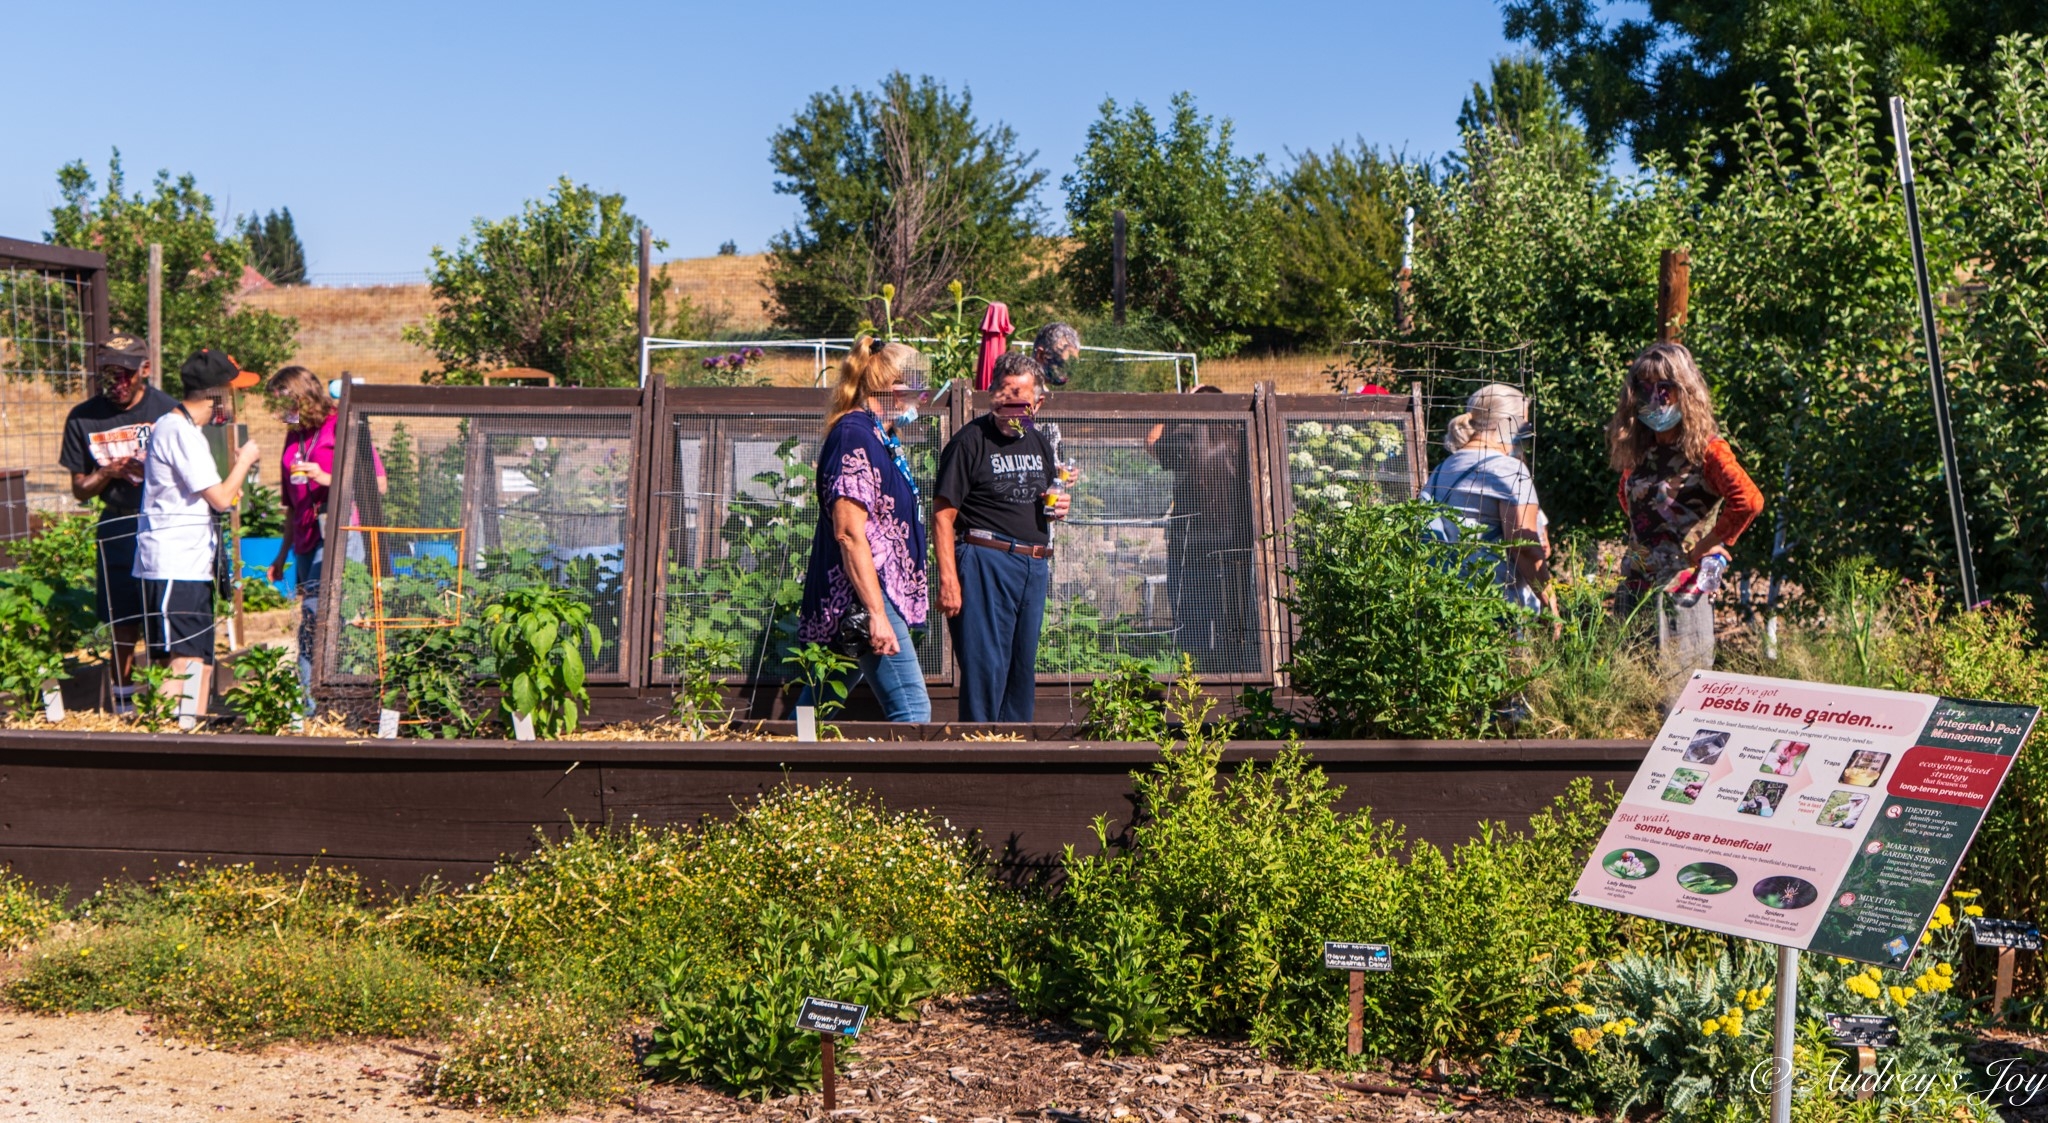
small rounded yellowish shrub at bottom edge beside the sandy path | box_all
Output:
[414,994,633,1115]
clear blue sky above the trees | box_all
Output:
[0,0,1511,281]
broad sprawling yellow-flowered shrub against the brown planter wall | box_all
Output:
[395,785,1014,1008]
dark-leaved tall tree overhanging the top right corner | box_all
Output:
[1501,0,2048,164]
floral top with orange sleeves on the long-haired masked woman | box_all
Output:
[1620,439,1763,592]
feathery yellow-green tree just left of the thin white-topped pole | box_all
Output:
[1270,141,1405,346]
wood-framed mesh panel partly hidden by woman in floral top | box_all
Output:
[653,389,946,682]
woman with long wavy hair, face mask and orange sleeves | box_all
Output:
[1608,342,1763,682]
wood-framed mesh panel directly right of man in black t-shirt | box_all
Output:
[983,393,1270,680]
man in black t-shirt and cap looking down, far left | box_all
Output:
[57,334,178,713]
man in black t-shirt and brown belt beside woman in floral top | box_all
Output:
[932,350,1069,721]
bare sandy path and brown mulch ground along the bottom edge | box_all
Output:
[0,998,1579,1123]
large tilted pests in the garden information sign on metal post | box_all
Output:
[1571,670,2040,967]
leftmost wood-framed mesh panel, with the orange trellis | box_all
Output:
[324,387,641,691]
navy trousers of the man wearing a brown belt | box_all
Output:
[946,543,1053,721]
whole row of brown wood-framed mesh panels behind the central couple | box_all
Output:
[317,381,1427,713]
